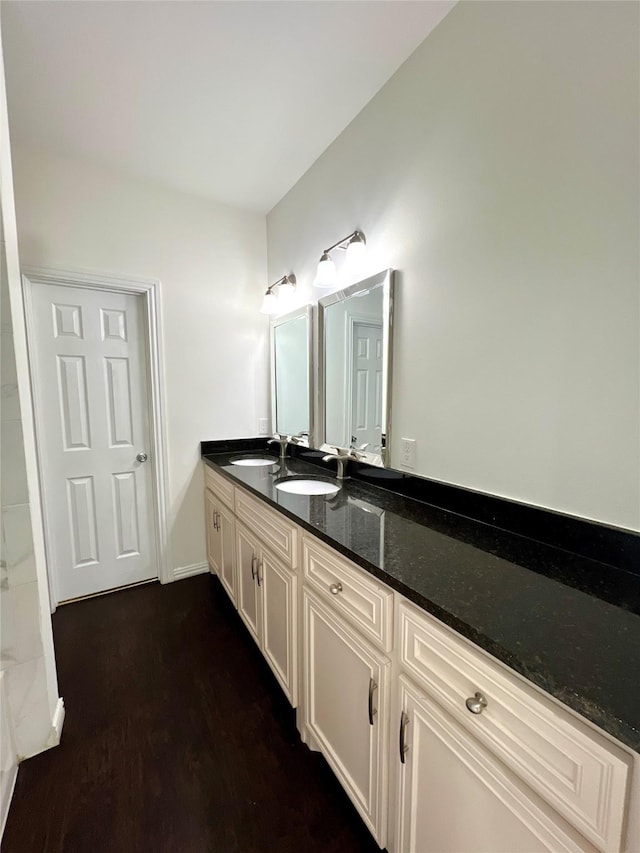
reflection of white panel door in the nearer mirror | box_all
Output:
[347,319,382,453]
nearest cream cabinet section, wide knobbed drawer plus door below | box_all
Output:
[395,601,631,853]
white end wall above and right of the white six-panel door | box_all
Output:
[14,148,269,568]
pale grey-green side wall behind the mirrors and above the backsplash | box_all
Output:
[267,2,640,529]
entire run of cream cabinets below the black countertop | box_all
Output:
[205,469,640,853]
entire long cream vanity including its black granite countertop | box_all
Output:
[202,442,640,853]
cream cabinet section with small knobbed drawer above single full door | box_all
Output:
[303,536,393,847]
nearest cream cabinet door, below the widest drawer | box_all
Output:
[395,676,595,853]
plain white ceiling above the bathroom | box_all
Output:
[2,0,454,213]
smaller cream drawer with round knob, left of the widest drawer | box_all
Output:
[302,536,393,652]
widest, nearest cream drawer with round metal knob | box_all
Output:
[398,601,631,853]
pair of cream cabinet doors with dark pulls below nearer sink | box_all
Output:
[236,521,298,707]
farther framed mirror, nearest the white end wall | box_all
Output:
[270,305,313,447]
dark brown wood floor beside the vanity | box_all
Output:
[2,575,378,853]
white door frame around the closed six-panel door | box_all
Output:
[22,267,174,613]
